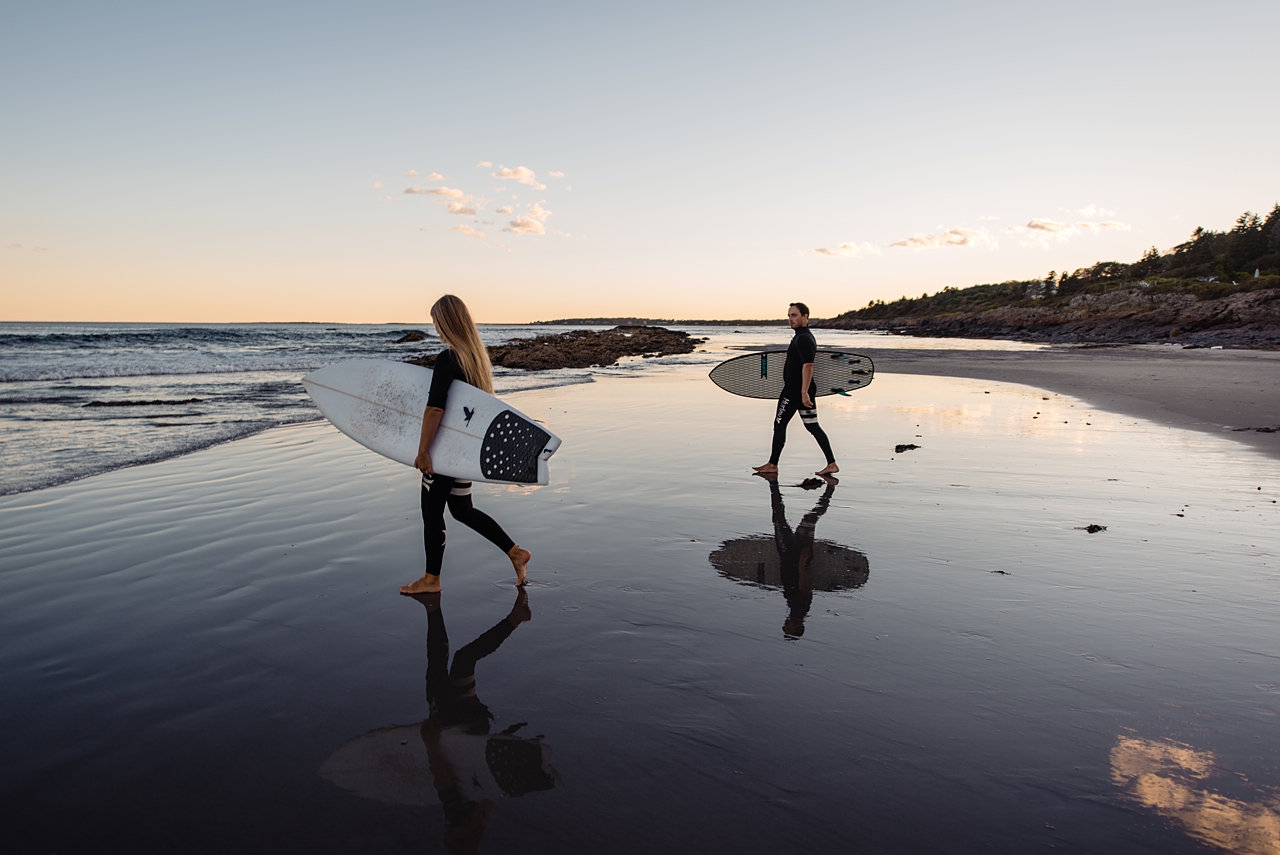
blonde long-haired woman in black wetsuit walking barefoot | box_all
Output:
[401,294,532,594]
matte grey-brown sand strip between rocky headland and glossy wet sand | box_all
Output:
[860,344,1280,457]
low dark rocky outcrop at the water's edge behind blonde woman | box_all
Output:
[410,326,707,371]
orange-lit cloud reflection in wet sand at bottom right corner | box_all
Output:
[1111,736,1280,855]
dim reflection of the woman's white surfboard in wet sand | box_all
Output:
[320,724,561,806]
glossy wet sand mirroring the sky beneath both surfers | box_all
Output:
[0,367,1280,852]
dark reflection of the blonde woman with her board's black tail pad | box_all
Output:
[415,587,557,852]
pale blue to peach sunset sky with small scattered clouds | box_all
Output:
[0,0,1280,323]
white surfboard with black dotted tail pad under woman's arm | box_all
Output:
[302,360,561,484]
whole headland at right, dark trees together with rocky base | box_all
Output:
[812,205,1280,347]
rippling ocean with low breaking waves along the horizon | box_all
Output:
[0,323,1039,495]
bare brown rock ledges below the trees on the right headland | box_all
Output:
[810,288,1280,349]
